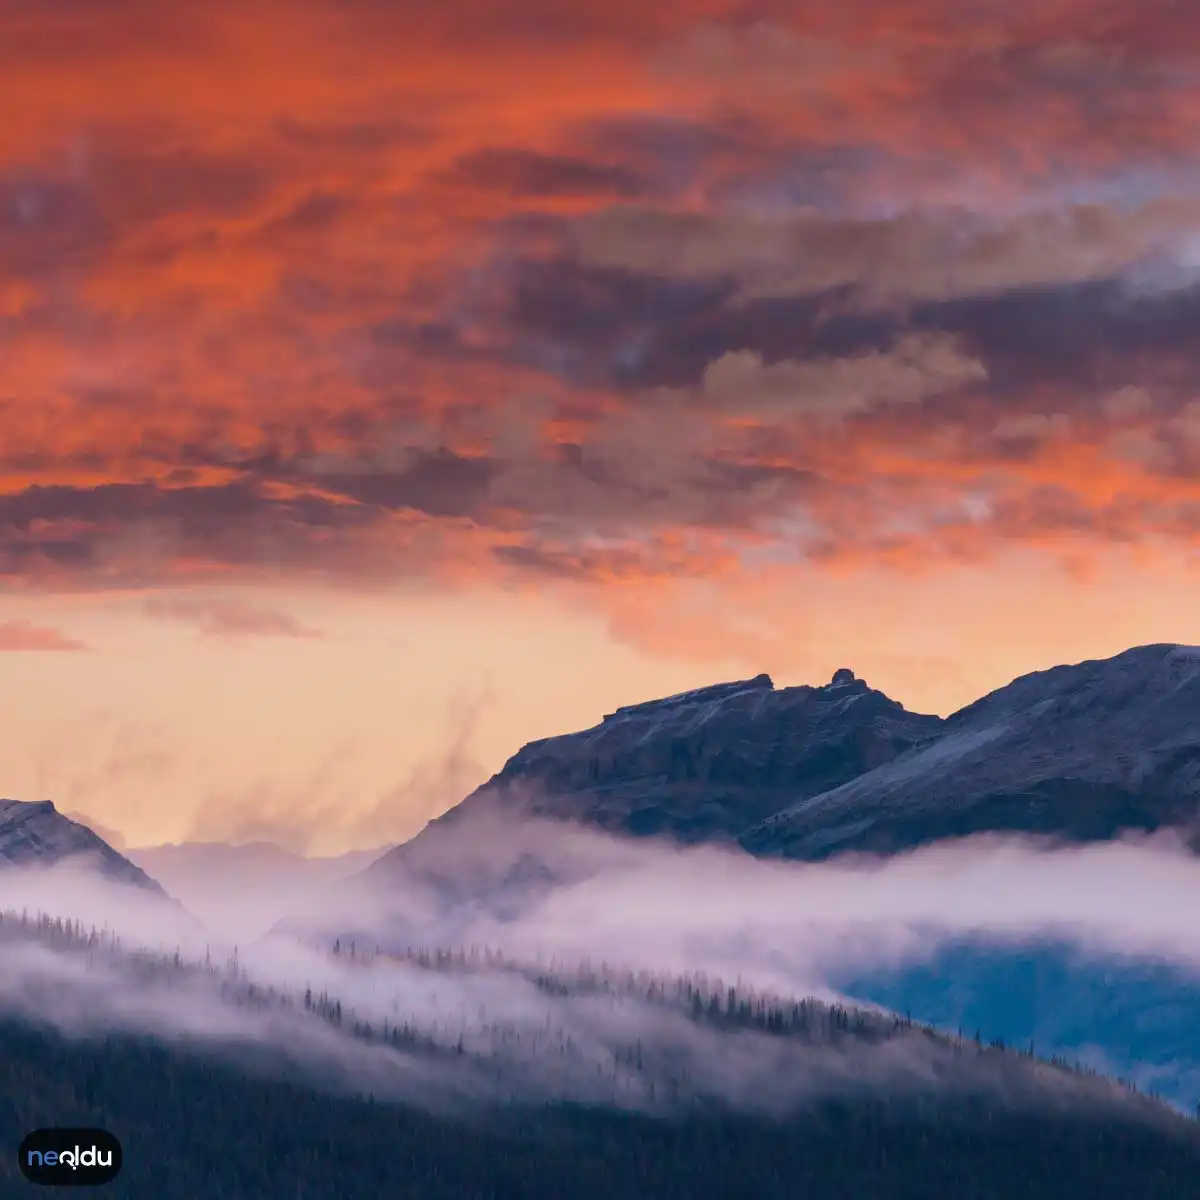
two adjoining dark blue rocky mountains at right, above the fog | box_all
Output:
[372,644,1200,874]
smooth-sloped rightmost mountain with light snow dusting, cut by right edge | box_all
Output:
[740,644,1200,859]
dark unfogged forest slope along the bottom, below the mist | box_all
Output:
[9,1022,1200,1200]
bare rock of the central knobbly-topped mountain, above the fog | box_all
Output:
[379,670,942,869]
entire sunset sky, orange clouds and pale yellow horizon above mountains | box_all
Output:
[0,0,1200,853]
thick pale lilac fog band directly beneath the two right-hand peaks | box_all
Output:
[308,811,1200,989]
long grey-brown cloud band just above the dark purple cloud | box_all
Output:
[561,198,1198,307]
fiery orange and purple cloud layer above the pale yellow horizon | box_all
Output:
[0,0,1200,632]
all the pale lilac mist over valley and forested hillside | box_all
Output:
[7,820,1200,1112]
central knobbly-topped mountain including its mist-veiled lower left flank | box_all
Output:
[357,670,942,916]
